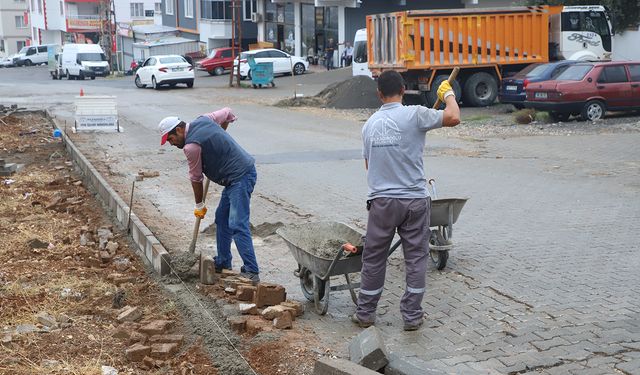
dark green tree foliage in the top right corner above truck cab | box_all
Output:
[530,0,640,33]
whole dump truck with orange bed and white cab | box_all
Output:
[366,5,613,107]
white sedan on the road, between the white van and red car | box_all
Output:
[135,55,195,89]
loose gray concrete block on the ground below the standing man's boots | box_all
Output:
[349,326,389,371]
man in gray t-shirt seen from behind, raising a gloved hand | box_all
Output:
[351,70,460,331]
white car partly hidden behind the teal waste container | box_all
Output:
[233,48,309,79]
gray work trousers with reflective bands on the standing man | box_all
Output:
[356,198,431,324]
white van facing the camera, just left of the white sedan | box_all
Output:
[62,44,109,79]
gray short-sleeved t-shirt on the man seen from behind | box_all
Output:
[362,103,443,199]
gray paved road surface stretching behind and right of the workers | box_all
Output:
[0,67,640,374]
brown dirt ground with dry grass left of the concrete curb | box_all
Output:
[0,113,316,375]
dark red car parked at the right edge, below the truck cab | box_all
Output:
[525,61,640,121]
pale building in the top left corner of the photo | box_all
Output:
[0,0,31,57]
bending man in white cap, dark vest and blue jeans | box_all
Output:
[158,108,260,283]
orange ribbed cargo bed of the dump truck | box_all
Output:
[367,5,561,73]
